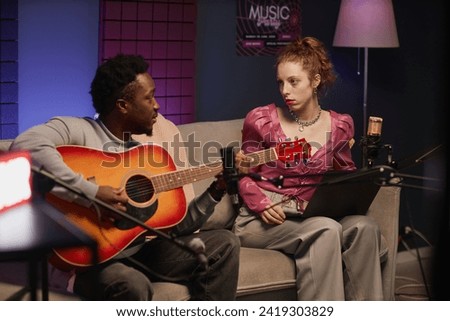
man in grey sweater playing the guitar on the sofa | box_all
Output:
[11,54,239,300]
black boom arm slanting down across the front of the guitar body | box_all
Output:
[31,165,208,270]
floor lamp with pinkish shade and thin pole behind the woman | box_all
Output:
[333,0,399,135]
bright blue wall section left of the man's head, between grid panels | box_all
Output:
[19,0,99,132]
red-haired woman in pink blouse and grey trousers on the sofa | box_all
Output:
[234,37,387,300]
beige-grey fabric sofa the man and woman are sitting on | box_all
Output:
[0,119,400,300]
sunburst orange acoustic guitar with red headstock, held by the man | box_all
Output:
[47,139,309,270]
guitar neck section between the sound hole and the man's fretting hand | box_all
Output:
[152,162,223,193]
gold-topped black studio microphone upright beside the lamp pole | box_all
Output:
[361,116,383,167]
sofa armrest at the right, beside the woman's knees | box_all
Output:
[367,186,401,300]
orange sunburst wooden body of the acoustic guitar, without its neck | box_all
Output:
[47,145,187,267]
